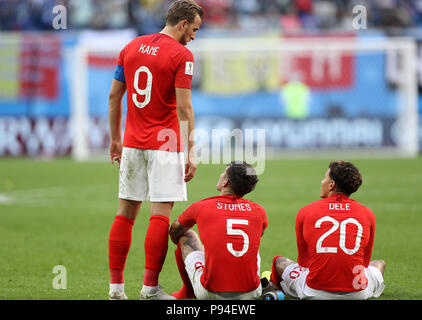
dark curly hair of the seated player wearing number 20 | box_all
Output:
[328,160,362,195]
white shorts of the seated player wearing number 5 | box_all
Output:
[185,251,262,300]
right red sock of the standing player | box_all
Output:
[144,215,169,287]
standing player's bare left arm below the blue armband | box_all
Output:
[109,79,126,166]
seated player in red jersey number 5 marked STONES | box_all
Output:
[170,162,268,300]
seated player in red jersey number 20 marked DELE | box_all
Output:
[271,161,385,300]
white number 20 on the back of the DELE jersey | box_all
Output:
[315,216,363,255]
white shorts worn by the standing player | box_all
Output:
[119,147,187,202]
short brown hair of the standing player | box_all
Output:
[166,0,204,26]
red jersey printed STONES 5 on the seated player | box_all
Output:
[179,196,268,292]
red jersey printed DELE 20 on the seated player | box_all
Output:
[296,193,375,291]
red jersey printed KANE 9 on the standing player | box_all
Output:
[117,33,194,152]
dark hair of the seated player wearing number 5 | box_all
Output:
[226,161,259,197]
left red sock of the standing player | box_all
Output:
[108,215,134,283]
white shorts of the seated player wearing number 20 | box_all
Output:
[280,263,385,300]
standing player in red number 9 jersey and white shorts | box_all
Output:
[109,0,203,299]
